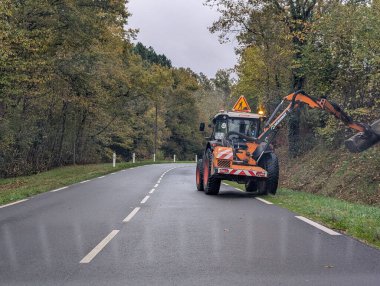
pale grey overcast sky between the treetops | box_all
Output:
[128,0,237,77]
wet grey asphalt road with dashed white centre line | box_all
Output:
[0,164,380,286]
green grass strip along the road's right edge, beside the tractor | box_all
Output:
[228,182,380,248]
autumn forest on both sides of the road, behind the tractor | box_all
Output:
[0,0,380,183]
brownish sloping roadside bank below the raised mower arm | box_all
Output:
[276,144,380,208]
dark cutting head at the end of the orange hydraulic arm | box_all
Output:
[344,119,380,153]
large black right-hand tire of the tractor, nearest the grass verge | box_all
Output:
[257,153,280,195]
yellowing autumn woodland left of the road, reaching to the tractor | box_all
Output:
[0,0,230,177]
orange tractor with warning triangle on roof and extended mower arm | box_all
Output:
[196,91,380,195]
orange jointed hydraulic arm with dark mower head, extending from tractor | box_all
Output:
[256,90,380,152]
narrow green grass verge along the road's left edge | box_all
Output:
[0,161,190,205]
